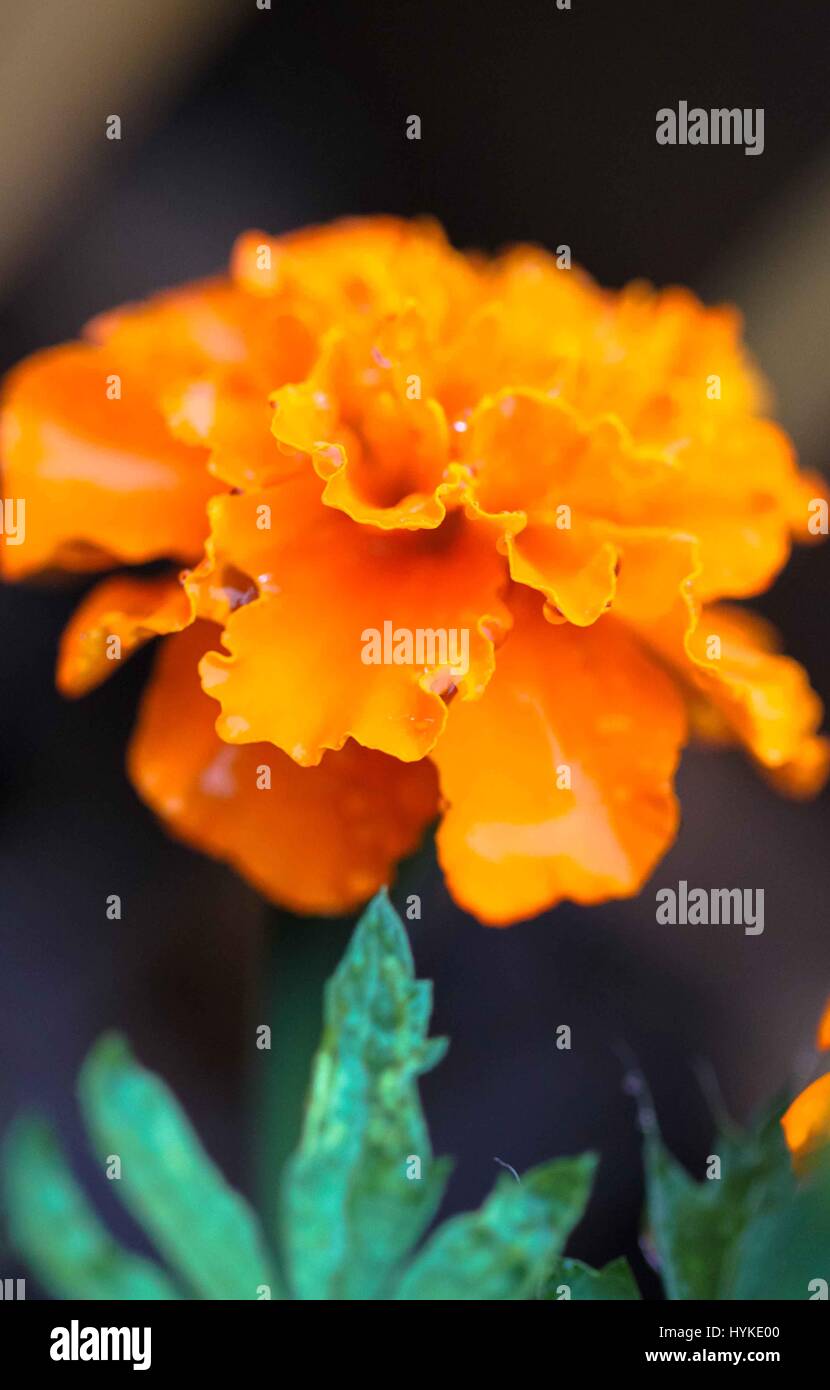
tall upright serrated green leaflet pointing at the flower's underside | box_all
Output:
[281,892,449,1300]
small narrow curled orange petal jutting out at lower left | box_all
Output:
[56,575,190,698]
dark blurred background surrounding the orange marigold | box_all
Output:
[0,0,830,1295]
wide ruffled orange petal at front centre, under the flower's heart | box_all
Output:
[195,475,510,766]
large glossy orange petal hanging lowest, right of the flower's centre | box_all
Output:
[432,591,685,924]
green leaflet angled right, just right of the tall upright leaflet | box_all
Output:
[395,1154,596,1301]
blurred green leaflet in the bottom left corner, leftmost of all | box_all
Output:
[3,1116,179,1300]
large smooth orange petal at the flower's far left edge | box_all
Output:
[0,343,218,578]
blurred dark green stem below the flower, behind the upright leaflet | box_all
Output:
[256,908,355,1238]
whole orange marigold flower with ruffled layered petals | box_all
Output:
[0,218,829,923]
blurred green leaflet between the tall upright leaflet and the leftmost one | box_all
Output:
[79,1034,281,1300]
